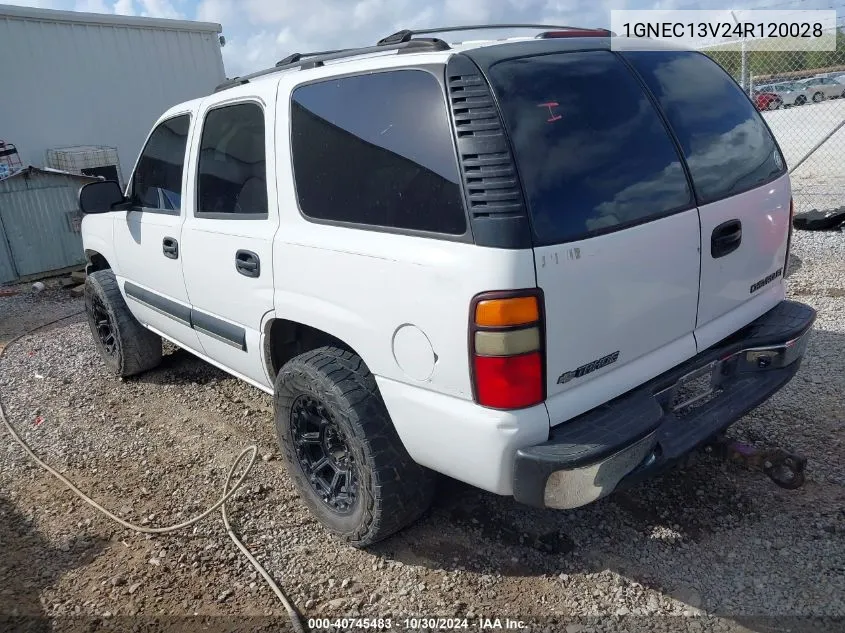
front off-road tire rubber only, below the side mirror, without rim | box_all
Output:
[85,270,161,376]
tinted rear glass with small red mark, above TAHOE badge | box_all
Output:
[489,51,692,244]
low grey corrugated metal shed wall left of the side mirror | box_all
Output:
[0,170,98,281]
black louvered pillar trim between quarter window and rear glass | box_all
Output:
[446,55,531,248]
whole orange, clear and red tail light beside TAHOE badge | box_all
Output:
[469,289,546,409]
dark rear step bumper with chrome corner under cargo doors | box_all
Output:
[513,301,816,508]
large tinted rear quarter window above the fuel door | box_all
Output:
[291,70,466,235]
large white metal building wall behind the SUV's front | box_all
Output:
[0,8,225,178]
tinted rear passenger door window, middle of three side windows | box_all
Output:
[197,103,267,216]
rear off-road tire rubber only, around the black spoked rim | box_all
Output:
[273,347,436,547]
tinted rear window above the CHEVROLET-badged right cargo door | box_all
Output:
[624,51,784,203]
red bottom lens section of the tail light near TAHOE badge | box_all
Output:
[475,352,543,409]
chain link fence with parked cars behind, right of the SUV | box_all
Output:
[702,25,845,212]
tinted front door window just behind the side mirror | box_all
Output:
[132,114,191,211]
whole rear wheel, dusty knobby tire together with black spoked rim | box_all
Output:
[274,347,435,547]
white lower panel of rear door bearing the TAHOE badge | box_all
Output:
[534,209,700,425]
